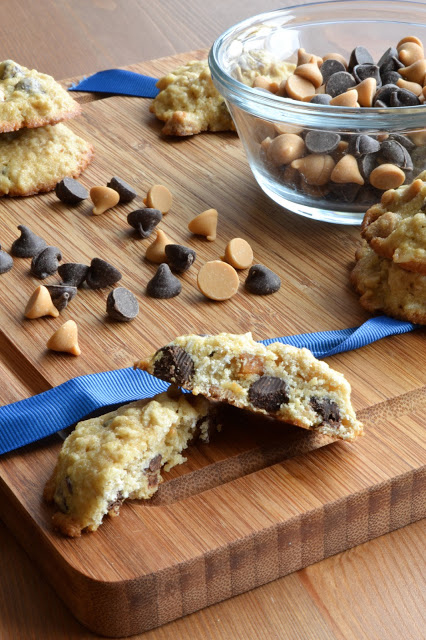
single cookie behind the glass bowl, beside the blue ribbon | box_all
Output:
[150,60,235,136]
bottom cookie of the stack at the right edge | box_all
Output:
[351,240,426,324]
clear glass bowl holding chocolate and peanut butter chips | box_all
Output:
[209,0,426,224]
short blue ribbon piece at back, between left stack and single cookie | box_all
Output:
[69,69,159,98]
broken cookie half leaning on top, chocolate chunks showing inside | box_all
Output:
[135,333,363,440]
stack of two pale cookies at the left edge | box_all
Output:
[0,60,93,196]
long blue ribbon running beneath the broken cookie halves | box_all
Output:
[0,316,420,454]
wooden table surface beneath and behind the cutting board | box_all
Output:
[0,0,426,640]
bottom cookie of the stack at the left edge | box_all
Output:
[0,124,93,196]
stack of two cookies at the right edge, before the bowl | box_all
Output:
[351,171,426,324]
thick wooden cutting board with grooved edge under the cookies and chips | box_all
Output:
[0,54,426,637]
